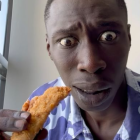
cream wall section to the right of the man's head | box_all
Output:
[126,0,140,73]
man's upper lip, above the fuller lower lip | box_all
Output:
[73,81,111,93]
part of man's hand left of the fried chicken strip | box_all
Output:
[0,109,30,140]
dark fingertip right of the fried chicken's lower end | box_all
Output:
[34,128,48,140]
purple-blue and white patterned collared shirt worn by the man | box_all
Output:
[29,69,140,140]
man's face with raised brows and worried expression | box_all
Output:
[47,0,130,111]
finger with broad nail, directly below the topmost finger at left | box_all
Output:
[0,117,28,132]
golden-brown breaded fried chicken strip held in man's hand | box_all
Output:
[11,87,71,140]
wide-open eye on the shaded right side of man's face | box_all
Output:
[99,31,117,42]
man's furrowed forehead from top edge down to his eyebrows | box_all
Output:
[48,0,126,35]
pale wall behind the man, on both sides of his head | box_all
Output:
[4,0,140,110]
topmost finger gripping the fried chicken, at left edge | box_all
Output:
[0,109,30,119]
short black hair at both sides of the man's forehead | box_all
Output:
[44,0,127,22]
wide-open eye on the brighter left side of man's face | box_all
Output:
[60,37,78,47]
